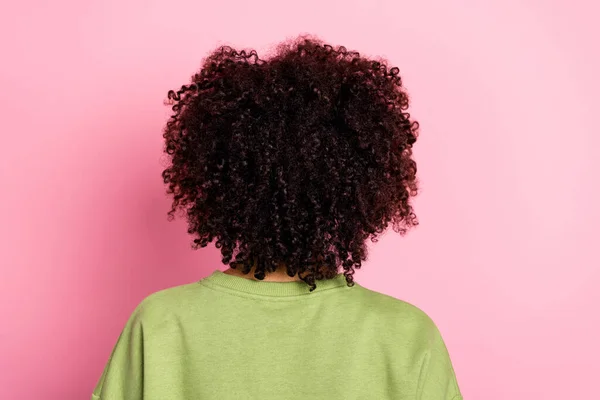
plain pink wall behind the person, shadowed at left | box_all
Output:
[0,0,600,400]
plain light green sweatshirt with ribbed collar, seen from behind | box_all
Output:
[92,270,462,400]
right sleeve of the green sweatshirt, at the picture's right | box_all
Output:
[417,326,463,400]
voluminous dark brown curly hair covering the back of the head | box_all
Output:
[162,35,419,292]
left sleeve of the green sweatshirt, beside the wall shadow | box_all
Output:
[92,304,144,400]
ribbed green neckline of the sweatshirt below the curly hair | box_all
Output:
[199,270,349,297]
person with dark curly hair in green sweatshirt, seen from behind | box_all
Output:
[92,35,462,400]
